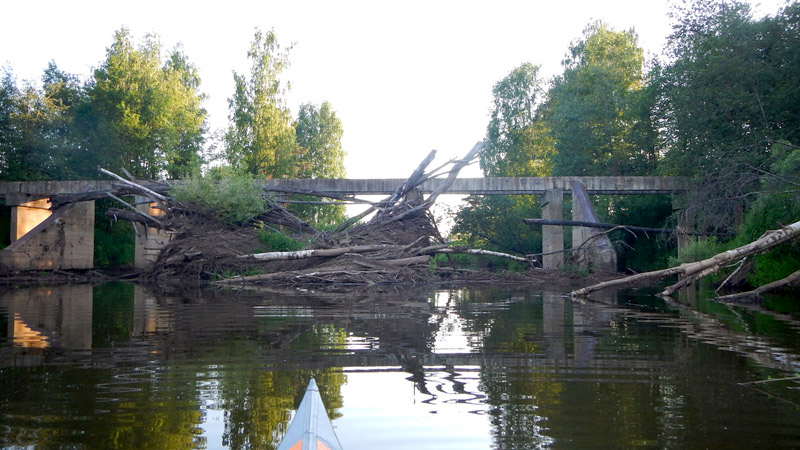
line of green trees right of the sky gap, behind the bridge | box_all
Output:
[454,0,800,278]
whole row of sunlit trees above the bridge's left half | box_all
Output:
[0,28,344,181]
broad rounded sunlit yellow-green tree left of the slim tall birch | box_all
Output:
[77,28,206,178]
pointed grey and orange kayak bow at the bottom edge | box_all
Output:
[278,378,343,450]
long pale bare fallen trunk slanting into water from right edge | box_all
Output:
[570,222,800,298]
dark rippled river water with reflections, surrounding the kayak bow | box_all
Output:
[0,284,800,450]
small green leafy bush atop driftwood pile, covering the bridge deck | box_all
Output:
[170,175,267,225]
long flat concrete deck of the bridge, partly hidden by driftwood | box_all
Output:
[0,176,688,198]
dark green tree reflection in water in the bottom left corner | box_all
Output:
[0,367,205,450]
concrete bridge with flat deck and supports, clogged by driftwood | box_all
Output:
[0,176,687,270]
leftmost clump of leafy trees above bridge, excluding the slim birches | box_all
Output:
[0,28,206,180]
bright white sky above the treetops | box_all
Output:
[0,0,783,178]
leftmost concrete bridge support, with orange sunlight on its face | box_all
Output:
[0,194,94,270]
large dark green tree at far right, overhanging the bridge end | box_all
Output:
[656,0,800,231]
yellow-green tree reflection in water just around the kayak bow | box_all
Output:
[219,325,346,449]
